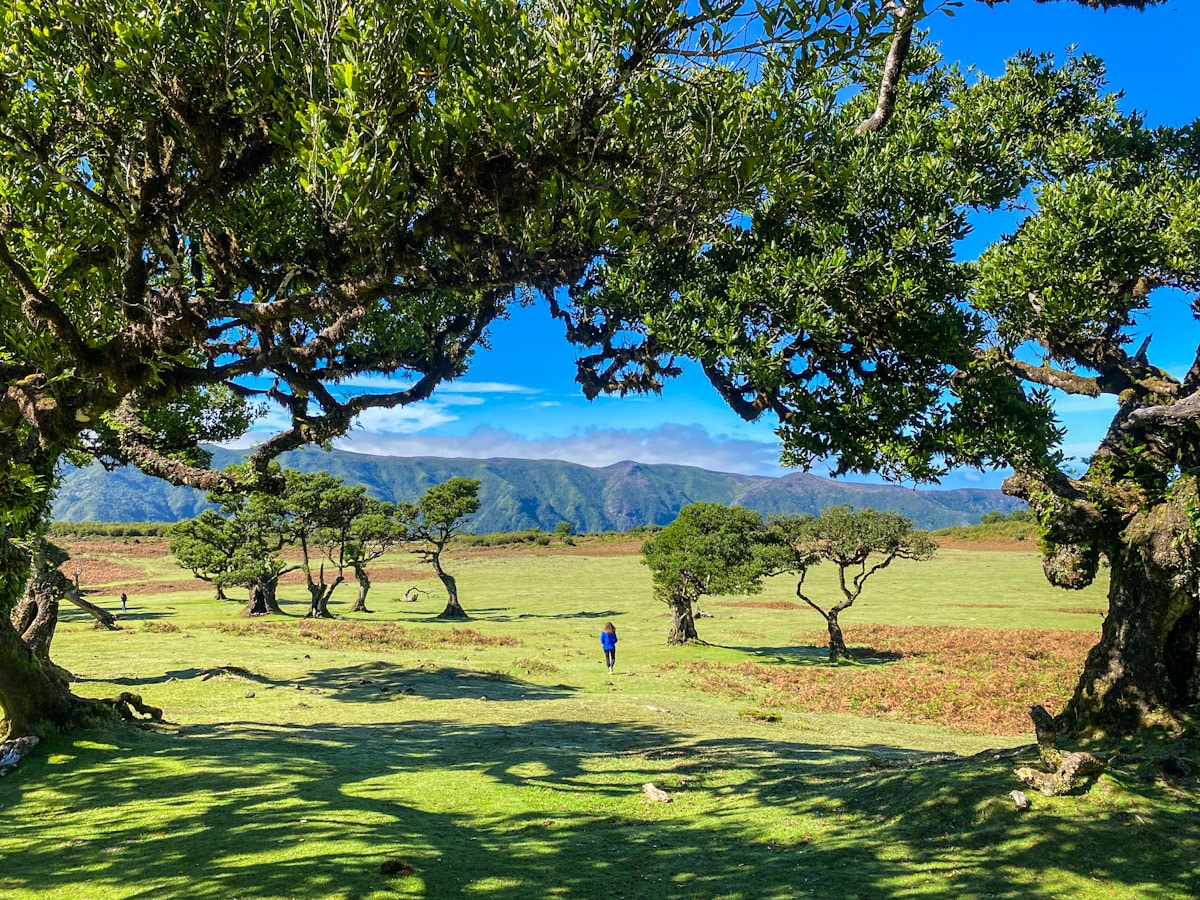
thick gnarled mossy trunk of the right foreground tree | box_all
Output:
[1062,502,1200,733]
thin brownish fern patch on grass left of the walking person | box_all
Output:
[205,619,521,650]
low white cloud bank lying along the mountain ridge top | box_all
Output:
[337,425,780,475]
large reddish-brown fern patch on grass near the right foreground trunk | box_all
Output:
[665,625,1096,734]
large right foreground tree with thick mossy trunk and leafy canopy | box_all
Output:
[581,42,1200,730]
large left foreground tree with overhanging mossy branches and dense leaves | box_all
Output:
[0,0,890,731]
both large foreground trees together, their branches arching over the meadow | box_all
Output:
[0,0,1200,733]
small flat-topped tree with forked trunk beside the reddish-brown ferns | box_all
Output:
[772,504,937,662]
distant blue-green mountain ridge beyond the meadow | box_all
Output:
[54,448,1024,534]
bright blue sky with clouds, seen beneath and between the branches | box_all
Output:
[267,0,1200,487]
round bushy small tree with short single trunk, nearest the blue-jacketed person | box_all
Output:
[642,503,768,643]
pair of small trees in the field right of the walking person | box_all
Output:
[642,503,937,661]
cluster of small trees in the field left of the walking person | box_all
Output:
[170,469,480,618]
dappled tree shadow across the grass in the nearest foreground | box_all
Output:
[0,718,1200,900]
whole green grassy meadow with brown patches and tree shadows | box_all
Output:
[0,539,1200,900]
